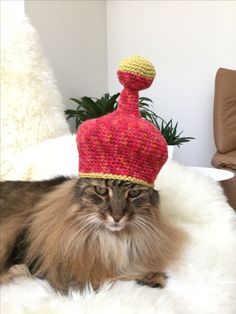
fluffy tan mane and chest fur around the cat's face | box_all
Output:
[0,179,185,293]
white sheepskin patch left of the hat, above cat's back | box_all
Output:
[4,134,79,181]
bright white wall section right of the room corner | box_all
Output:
[107,1,236,166]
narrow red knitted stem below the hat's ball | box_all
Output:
[117,87,141,117]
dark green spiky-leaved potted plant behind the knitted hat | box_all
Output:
[65,93,194,159]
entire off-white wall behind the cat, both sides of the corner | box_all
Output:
[12,0,236,166]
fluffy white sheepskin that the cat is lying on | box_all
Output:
[1,141,236,314]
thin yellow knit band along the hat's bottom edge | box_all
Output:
[79,172,154,188]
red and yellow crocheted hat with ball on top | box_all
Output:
[77,56,167,187]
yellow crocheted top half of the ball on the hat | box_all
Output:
[118,56,156,79]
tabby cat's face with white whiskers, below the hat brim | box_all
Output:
[75,178,159,231]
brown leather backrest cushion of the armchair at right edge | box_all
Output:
[214,68,236,154]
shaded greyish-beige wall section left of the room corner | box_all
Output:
[25,0,107,131]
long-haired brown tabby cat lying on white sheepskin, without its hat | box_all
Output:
[0,177,186,294]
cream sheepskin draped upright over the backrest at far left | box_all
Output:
[0,11,70,179]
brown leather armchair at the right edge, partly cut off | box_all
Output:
[212,68,236,210]
